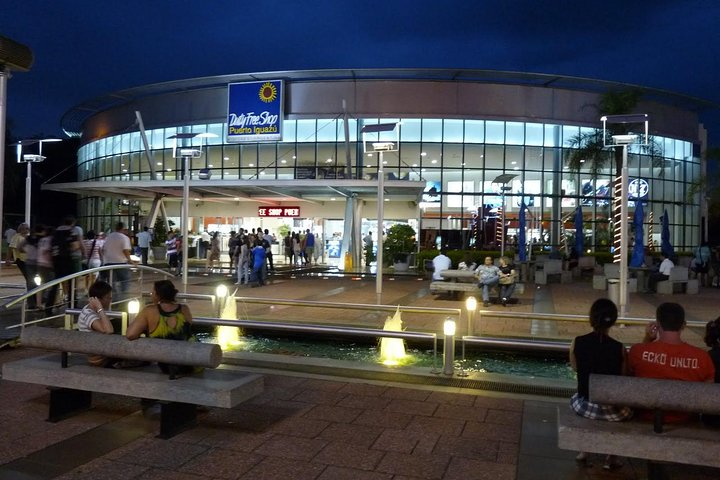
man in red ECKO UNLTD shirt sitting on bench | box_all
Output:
[628,303,715,423]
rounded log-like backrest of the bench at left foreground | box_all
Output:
[20,327,222,368]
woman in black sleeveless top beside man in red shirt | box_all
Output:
[570,298,633,470]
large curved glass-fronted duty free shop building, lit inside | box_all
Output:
[53,70,704,255]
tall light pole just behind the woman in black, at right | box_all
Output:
[600,113,649,317]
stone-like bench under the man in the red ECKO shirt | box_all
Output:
[558,375,720,480]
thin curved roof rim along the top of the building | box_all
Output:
[60,68,720,136]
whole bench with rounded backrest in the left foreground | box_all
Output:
[2,327,263,438]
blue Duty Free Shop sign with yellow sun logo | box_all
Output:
[226,80,283,142]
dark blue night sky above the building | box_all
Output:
[0,0,720,145]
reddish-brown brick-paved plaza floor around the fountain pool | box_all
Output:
[0,266,720,480]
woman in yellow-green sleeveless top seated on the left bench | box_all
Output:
[127,280,193,376]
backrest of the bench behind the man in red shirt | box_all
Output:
[590,374,720,414]
